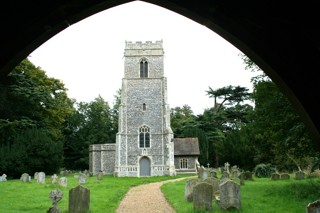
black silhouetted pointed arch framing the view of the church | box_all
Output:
[0,0,320,148]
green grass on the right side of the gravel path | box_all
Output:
[161,176,320,213]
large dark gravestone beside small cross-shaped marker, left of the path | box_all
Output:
[69,185,90,213]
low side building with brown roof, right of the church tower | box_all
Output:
[173,138,200,174]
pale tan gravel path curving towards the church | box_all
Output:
[116,178,186,213]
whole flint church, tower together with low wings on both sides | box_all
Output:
[89,40,200,177]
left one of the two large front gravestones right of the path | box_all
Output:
[192,183,213,211]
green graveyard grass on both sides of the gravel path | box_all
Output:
[0,175,320,213]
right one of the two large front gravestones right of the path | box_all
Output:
[219,180,241,210]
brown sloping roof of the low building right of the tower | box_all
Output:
[173,138,200,155]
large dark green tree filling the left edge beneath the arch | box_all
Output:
[0,59,72,177]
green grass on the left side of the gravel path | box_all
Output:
[0,175,190,213]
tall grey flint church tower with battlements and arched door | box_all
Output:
[114,41,175,177]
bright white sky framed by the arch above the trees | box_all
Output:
[29,1,253,115]
